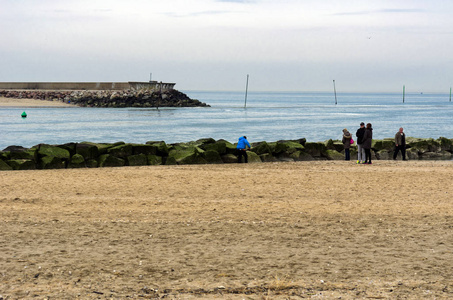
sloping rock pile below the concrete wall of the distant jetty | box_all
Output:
[0,89,209,107]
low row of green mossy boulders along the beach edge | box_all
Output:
[0,137,453,170]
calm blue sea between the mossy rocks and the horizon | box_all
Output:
[0,91,453,149]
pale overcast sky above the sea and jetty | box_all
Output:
[0,0,453,93]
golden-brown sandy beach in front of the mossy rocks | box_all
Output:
[0,161,453,299]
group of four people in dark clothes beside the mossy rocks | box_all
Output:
[342,122,406,165]
